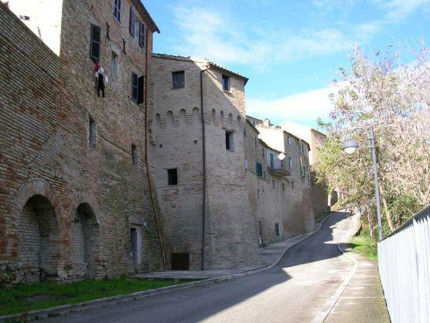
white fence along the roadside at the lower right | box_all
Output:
[378,206,430,323]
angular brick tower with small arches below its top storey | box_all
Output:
[150,55,258,269]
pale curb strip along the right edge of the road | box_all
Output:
[312,211,360,323]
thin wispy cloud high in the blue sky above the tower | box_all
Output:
[174,5,353,70]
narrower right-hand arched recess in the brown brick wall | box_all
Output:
[72,203,100,279]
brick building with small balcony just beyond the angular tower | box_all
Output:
[245,118,315,245]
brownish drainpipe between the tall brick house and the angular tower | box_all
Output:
[144,28,167,270]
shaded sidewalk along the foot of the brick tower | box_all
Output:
[135,233,310,280]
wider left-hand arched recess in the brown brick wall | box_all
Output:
[18,194,60,282]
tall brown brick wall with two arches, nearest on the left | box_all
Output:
[0,0,161,284]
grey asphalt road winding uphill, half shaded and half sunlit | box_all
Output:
[48,213,353,323]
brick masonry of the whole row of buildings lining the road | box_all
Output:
[0,0,326,284]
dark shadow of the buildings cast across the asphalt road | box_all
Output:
[48,212,350,322]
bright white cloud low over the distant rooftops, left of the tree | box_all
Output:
[246,87,336,128]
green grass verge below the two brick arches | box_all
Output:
[0,279,185,315]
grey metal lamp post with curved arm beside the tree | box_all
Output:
[342,125,382,241]
